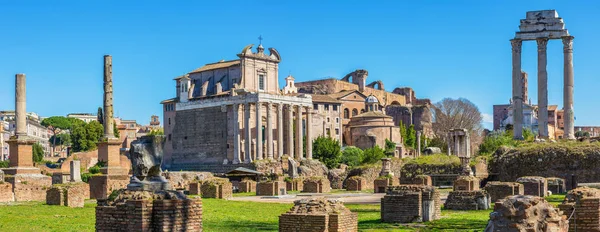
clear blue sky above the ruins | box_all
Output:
[0,0,600,128]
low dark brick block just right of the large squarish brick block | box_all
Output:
[444,190,491,210]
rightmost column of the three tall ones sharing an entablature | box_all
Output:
[563,36,575,139]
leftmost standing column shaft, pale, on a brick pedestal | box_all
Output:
[14,73,27,138]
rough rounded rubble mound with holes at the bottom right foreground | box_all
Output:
[485,195,568,232]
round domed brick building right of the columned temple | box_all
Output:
[346,95,402,149]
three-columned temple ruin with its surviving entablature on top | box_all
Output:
[510,10,575,139]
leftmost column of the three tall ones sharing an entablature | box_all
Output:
[510,39,525,140]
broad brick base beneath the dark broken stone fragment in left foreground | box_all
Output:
[96,198,202,232]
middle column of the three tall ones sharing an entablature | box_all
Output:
[537,38,548,139]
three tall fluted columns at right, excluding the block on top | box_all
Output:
[511,36,575,139]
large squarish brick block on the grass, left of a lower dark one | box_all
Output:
[381,185,442,223]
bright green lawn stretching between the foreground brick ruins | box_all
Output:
[0,199,491,232]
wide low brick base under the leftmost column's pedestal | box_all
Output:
[5,174,52,201]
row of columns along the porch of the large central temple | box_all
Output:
[233,102,312,164]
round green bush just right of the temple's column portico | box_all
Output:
[313,136,342,168]
